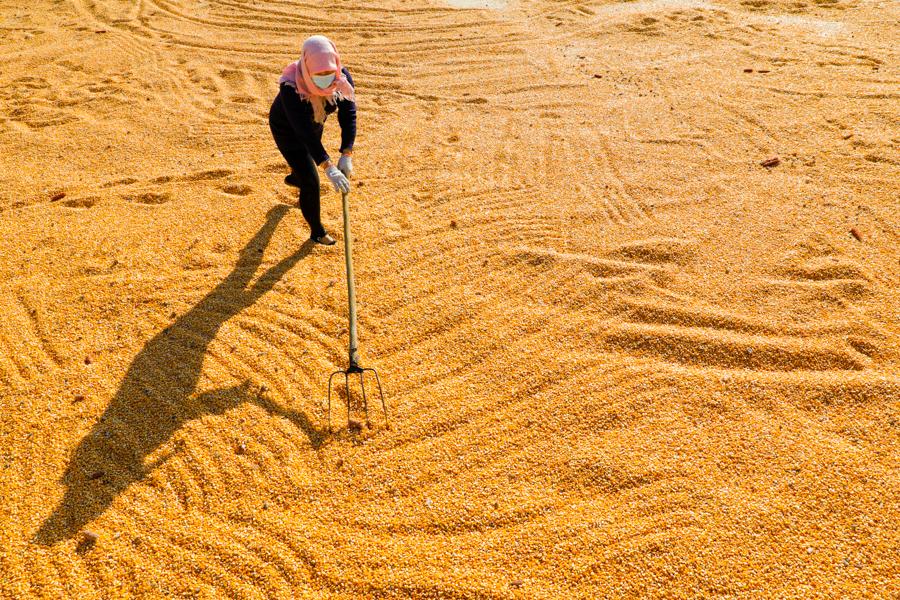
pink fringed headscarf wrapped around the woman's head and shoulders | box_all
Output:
[278,35,356,123]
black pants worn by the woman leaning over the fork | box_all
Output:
[269,93,325,237]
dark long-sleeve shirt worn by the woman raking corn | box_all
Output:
[280,67,356,165]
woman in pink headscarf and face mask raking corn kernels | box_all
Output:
[269,35,356,246]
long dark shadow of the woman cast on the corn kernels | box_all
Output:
[34,205,324,545]
